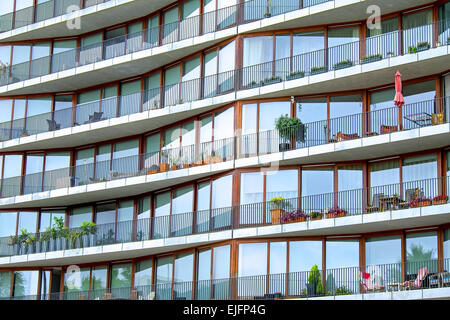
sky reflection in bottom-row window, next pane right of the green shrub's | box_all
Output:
[326,240,359,269]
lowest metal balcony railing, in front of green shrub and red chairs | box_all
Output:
[0,258,450,300]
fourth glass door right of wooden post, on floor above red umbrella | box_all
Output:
[328,26,360,70]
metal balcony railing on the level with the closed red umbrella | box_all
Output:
[0,98,450,198]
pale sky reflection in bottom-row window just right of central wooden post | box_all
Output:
[238,243,267,277]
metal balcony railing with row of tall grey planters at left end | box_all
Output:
[0,176,450,256]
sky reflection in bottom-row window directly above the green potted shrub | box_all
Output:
[289,241,322,273]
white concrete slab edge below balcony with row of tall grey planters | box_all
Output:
[0,204,450,268]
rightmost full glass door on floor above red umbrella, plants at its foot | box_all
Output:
[402,9,433,54]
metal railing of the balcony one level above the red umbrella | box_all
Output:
[0,22,450,141]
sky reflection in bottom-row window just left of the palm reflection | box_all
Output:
[366,236,402,266]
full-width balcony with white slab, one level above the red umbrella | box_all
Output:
[0,20,448,150]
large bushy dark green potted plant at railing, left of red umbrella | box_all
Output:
[275,114,306,151]
